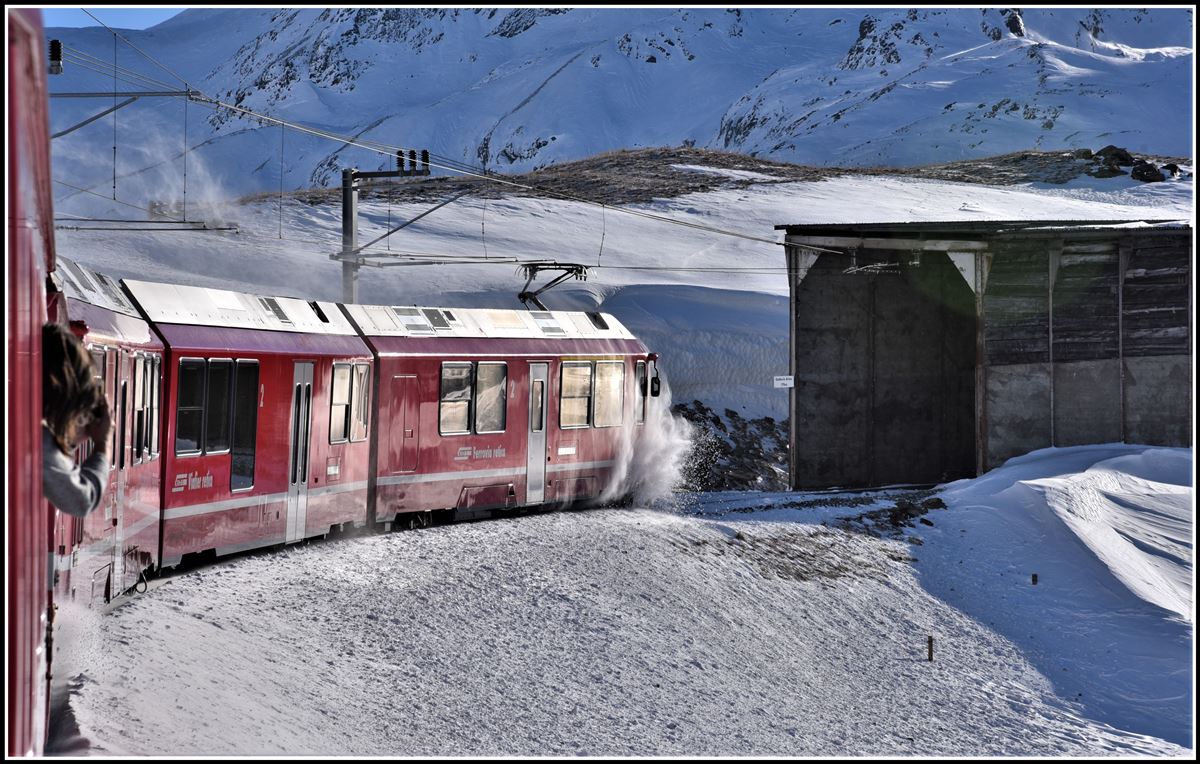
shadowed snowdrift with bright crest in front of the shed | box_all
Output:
[918,444,1195,742]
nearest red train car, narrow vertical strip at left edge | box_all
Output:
[5,8,55,756]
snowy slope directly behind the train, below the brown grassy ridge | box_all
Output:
[51,163,1193,419]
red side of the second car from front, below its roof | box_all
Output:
[158,325,371,565]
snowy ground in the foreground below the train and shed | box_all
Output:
[54,445,1194,758]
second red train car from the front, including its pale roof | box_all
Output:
[124,279,372,566]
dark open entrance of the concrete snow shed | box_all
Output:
[792,249,976,488]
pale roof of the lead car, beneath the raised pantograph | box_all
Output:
[342,305,635,339]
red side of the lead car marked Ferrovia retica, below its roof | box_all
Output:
[370,337,646,522]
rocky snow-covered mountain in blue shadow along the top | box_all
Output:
[48,7,1194,195]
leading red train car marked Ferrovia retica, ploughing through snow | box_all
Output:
[342,305,649,524]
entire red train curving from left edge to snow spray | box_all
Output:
[7,10,659,756]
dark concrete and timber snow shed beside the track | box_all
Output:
[788,224,1194,488]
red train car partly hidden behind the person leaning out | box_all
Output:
[55,258,163,603]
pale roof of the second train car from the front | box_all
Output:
[122,278,356,335]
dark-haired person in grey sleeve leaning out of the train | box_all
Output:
[42,324,113,517]
